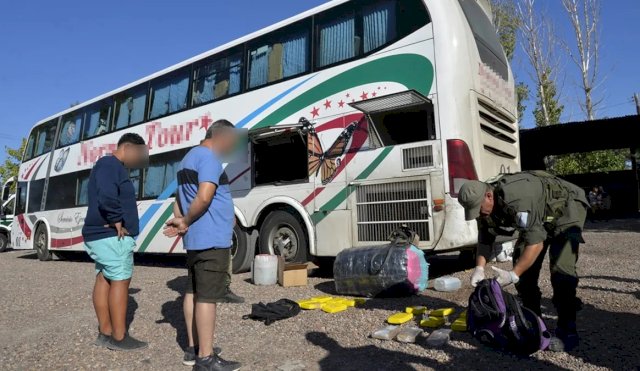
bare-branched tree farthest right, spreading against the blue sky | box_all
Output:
[562,0,602,121]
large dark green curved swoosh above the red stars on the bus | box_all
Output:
[251,54,434,130]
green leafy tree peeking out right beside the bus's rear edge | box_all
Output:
[491,0,529,118]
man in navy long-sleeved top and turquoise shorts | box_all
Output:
[82,133,148,350]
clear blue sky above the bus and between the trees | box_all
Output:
[0,0,640,161]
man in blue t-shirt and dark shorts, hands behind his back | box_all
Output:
[165,120,244,371]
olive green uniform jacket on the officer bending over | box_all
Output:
[478,172,588,246]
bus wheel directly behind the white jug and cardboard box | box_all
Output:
[259,210,307,263]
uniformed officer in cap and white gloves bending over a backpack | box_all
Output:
[458,171,588,351]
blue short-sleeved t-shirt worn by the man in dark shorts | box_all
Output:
[178,146,235,250]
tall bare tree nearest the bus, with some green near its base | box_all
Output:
[517,0,564,126]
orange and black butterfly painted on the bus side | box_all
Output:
[300,117,367,185]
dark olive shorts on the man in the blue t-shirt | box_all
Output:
[186,248,231,303]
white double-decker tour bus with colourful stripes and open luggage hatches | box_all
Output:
[11,0,520,272]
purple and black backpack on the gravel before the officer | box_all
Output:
[467,279,551,355]
